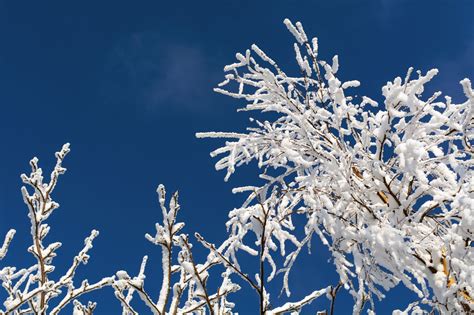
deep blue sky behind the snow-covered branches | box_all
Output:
[0,0,474,314]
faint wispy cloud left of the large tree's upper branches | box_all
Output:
[102,32,220,111]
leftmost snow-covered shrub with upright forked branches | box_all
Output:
[0,144,114,315]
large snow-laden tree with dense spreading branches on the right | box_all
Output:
[197,20,474,314]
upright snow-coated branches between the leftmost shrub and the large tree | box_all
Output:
[113,185,240,315]
